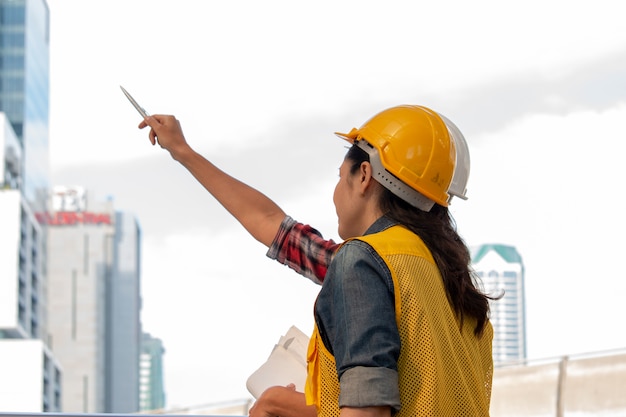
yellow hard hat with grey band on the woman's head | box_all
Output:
[336,105,456,211]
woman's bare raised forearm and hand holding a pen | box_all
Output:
[139,115,285,247]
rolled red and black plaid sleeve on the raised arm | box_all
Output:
[267,216,339,284]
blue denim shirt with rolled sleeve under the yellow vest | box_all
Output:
[315,216,400,410]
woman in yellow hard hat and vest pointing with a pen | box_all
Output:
[139,106,492,417]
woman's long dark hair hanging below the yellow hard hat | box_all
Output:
[346,146,499,335]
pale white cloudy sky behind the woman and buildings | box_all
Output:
[48,0,626,407]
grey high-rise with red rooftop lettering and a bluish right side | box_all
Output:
[45,187,141,413]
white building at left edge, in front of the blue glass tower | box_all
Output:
[0,112,62,412]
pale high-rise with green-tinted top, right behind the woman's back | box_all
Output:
[472,244,526,364]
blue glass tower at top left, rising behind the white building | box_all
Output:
[0,0,50,211]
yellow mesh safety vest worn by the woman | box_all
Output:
[305,226,493,417]
